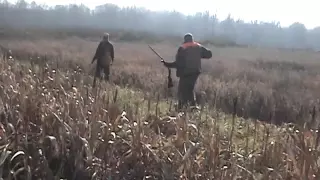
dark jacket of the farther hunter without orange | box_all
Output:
[92,41,114,66]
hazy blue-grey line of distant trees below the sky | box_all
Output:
[0,0,320,50]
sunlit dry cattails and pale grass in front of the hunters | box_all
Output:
[0,50,320,180]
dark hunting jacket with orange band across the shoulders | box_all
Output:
[165,41,212,77]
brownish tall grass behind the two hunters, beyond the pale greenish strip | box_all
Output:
[1,37,320,126]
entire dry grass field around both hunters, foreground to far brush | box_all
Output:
[0,32,320,180]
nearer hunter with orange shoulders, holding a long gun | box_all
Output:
[163,33,212,109]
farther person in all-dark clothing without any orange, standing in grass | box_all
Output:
[91,33,114,86]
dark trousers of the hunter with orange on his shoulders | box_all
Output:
[178,73,199,110]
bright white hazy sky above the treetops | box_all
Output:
[9,0,320,29]
